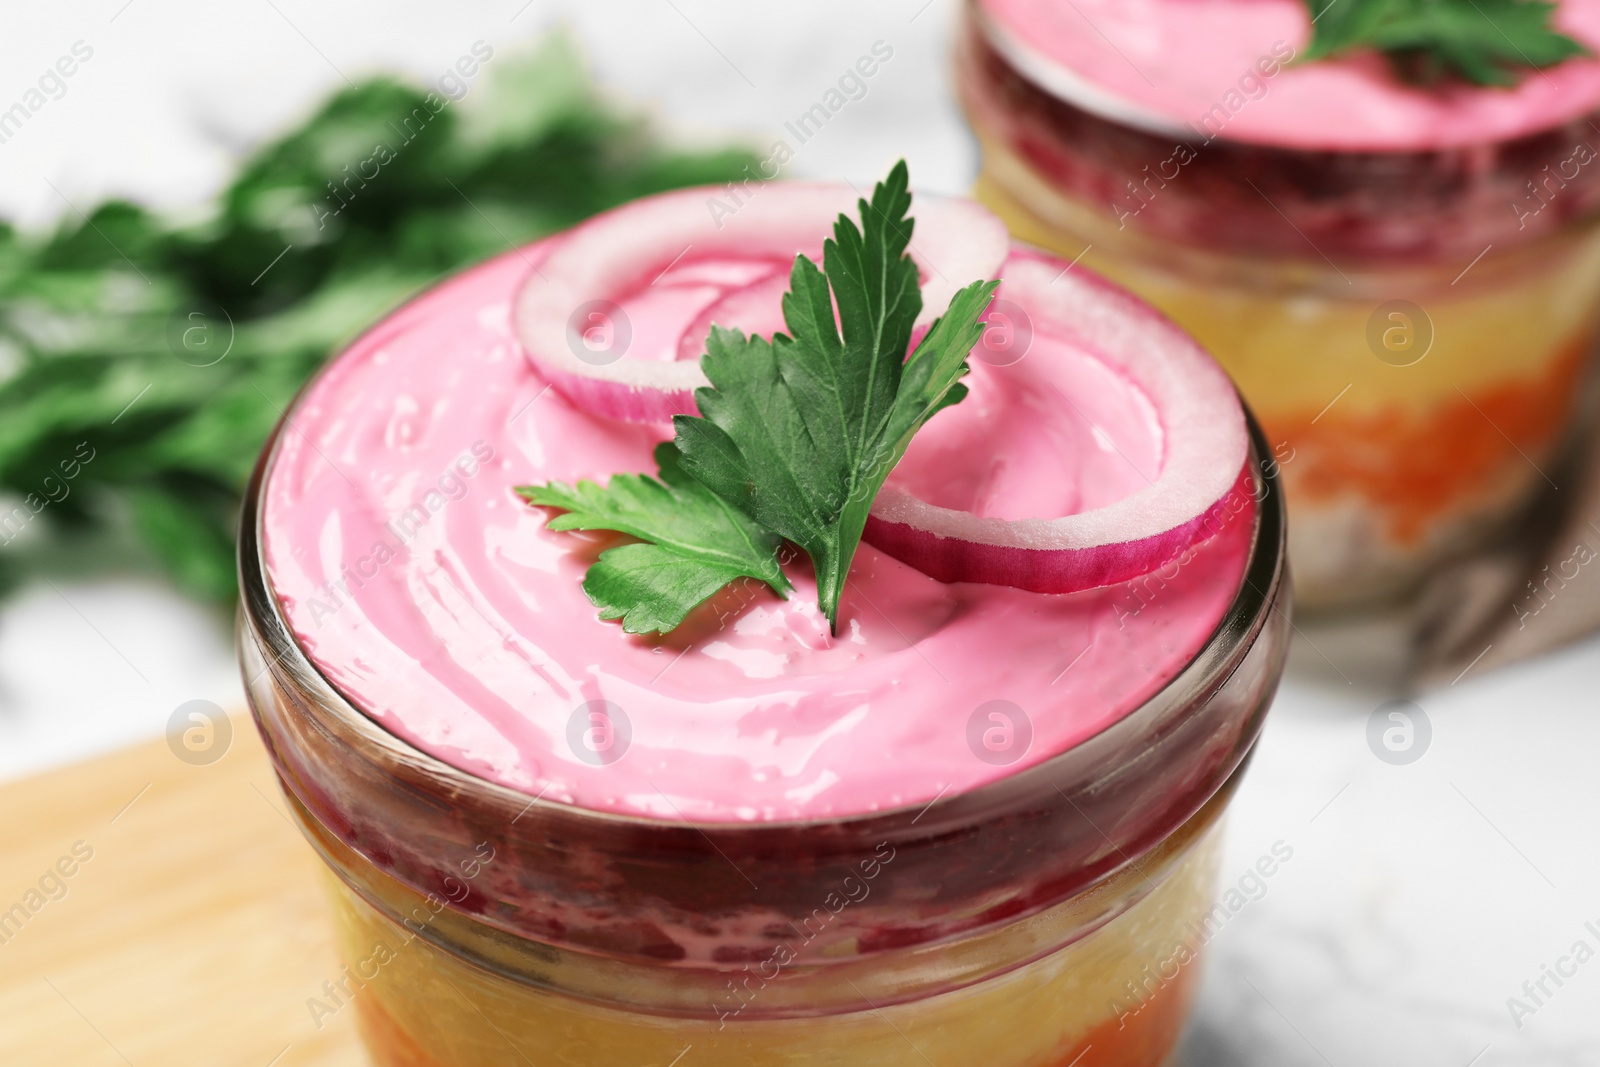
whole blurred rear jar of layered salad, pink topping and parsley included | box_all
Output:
[957,0,1600,609]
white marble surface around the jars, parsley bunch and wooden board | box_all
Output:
[0,0,1600,1067]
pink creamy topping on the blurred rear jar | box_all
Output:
[979,0,1600,150]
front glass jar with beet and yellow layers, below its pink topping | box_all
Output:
[240,395,1290,1067]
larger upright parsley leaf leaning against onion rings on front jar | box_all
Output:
[674,162,998,629]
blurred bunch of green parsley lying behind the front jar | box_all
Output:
[0,37,755,601]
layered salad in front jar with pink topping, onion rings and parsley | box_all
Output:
[259,165,1280,1067]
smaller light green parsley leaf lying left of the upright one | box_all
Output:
[517,442,792,633]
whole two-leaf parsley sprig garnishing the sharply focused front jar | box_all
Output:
[518,162,998,633]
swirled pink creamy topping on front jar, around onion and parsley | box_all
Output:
[262,243,1251,821]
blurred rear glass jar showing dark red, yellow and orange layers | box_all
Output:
[957,0,1600,608]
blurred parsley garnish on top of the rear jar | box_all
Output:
[1304,0,1592,85]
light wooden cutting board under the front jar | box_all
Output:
[0,717,368,1067]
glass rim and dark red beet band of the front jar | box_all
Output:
[238,254,1288,958]
